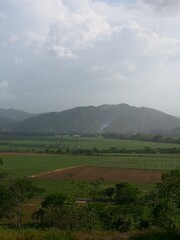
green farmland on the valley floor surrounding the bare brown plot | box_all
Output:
[0,136,180,195]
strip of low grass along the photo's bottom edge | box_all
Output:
[0,228,179,240]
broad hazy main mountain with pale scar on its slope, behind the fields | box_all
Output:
[13,104,180,134]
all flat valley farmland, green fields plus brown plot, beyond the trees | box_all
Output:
[0,136,180,239]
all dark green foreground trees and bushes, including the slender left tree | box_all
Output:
[0,170,180,239]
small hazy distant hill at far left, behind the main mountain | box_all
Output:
[0,108,35,122]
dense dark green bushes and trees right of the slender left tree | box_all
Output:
[30,170,180,232]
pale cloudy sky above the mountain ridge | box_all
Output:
[0,0,180,116]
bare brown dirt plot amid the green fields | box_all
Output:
[32,165,162,183]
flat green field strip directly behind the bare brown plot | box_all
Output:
[0,153,180,177]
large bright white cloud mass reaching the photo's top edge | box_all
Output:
[9,0,118,58]
